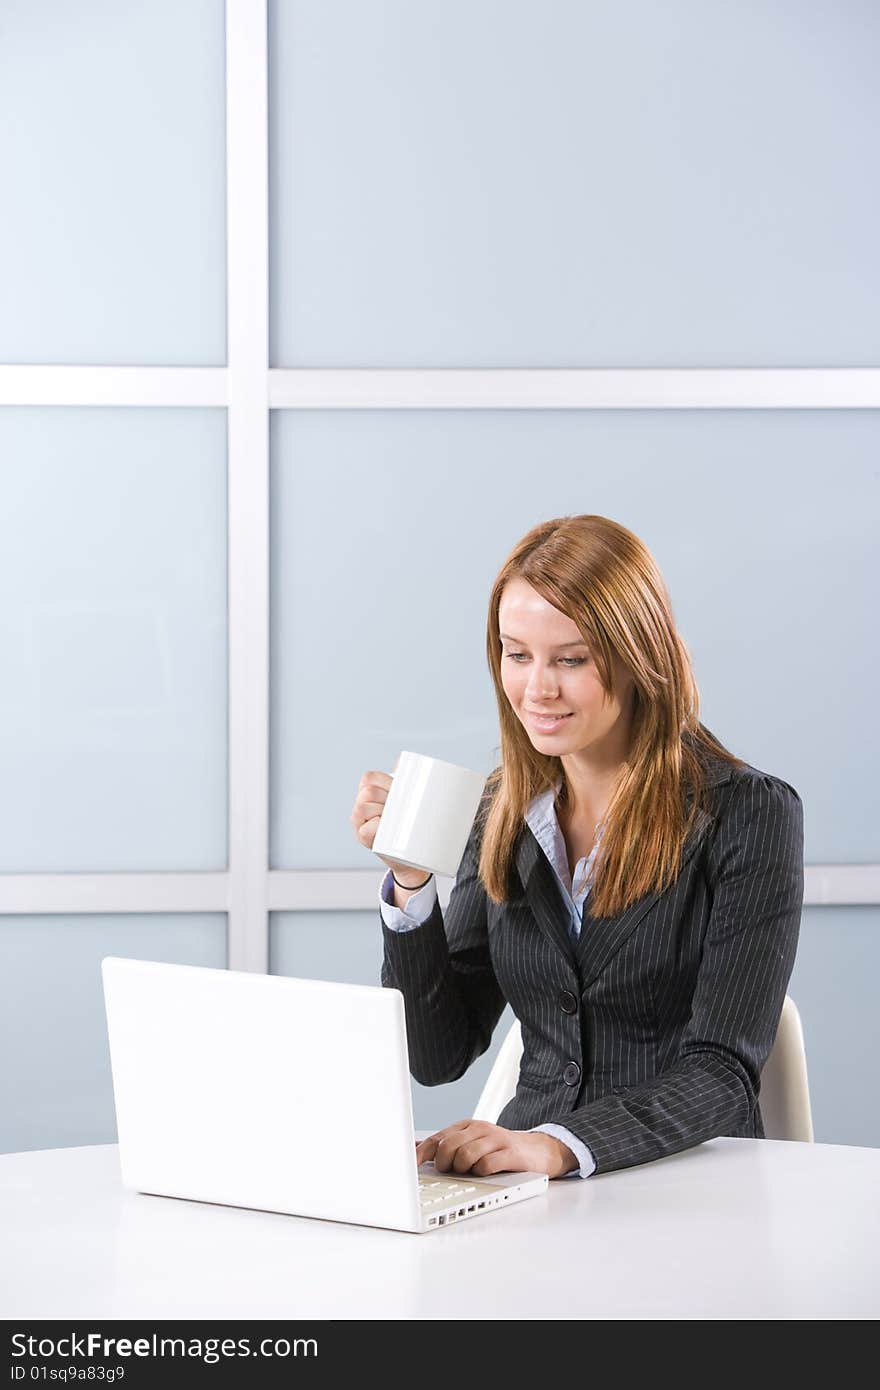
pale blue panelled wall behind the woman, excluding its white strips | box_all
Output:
[0,0,880,1150]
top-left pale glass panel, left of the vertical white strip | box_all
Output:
[0,0,227,366]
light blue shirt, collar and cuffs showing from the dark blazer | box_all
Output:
[380,783,605,1177]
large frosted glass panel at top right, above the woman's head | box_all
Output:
[268,0,880,367]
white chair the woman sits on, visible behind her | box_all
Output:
[474,994,813,1144]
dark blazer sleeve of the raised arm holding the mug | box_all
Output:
[380,819,506,1086]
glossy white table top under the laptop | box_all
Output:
[0,1138,880,1321]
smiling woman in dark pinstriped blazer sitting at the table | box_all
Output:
[352,516,804,1177]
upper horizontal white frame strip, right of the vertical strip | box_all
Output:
[268,367,880,410]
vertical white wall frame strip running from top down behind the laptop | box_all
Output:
[227,0,270,972]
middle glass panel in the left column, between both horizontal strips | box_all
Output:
[0,407,227,873]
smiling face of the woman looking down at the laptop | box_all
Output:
[499,580,634,760]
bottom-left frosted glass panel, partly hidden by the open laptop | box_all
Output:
[0,912,227,1152]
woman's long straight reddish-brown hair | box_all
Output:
[480,516,745,917]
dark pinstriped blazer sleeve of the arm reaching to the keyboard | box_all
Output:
[546,774,804,1173]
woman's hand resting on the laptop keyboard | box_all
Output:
[416,1120,578,1177]
